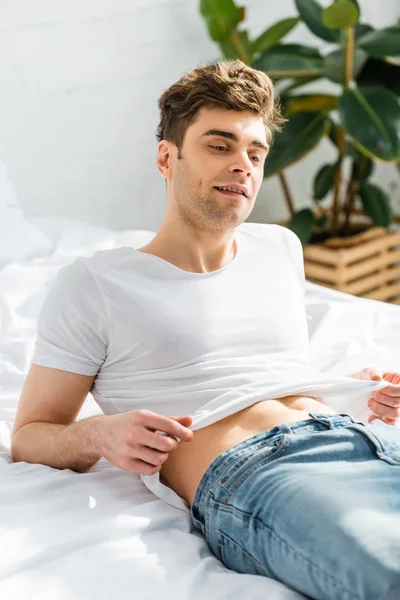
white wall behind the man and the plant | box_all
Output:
[0,0,400,229]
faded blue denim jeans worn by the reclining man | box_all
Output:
[190,413,400,600]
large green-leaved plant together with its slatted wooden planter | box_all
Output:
[200,0,400,304]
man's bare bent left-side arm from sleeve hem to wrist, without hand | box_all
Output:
[11,365,106,472]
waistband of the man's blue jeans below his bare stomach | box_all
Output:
[191,413,361,514]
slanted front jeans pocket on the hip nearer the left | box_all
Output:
[220,432,290,494]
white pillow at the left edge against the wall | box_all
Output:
[0,160,53,266]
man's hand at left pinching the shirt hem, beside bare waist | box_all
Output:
[98,410,194,475]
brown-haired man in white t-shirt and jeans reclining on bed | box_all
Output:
[12,61,400,600]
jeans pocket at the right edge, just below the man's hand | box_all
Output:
[351,419,400,466]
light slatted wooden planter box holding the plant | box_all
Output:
[303,227,400,304]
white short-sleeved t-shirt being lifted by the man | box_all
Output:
[32,223,388,512]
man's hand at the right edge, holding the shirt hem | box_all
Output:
[349,367,400,425]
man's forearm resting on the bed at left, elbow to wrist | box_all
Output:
[11,415,107,473]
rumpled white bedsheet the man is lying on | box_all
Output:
[0,218,400,600]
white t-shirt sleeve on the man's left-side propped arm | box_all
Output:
[32,258,109,375]
